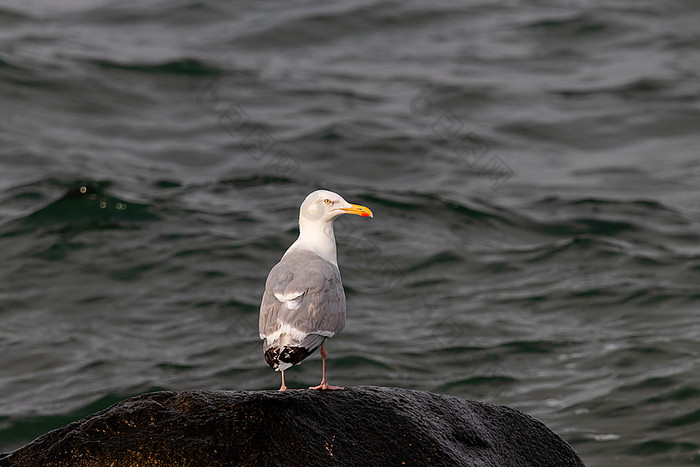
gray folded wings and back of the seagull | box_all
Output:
[258,251,345,352]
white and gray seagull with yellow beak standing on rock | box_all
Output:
[258,190,374,391]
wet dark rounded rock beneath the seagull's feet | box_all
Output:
[0,386,583,467]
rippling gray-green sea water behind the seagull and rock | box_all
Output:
[0,0,700,466]
